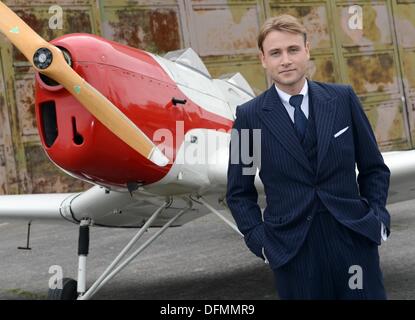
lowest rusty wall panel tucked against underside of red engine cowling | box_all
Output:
[25,144,91,193]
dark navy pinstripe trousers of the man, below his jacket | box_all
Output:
[273,211,386,300]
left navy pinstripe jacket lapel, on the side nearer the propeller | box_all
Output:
[257,85,312,172]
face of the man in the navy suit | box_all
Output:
[260,30,310,94]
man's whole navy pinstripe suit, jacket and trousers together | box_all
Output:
[226,80,390,298]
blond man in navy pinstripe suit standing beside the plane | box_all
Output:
[226,15,390,299]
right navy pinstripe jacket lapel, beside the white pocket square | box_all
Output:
[308,81,337,175]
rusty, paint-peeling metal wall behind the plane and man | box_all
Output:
[0,0,415,194]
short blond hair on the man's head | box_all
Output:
[258,14,307,52]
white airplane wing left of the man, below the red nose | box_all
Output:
[0,186,208,228]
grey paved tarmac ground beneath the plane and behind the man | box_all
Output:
[0,200,415,300]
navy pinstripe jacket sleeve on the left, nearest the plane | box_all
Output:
[226,107,264,259]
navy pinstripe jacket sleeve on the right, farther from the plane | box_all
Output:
[349,87,390,236]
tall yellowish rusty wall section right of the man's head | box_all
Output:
[332,0,411,151]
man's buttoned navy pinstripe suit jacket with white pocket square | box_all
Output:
[226,80,390,268]
